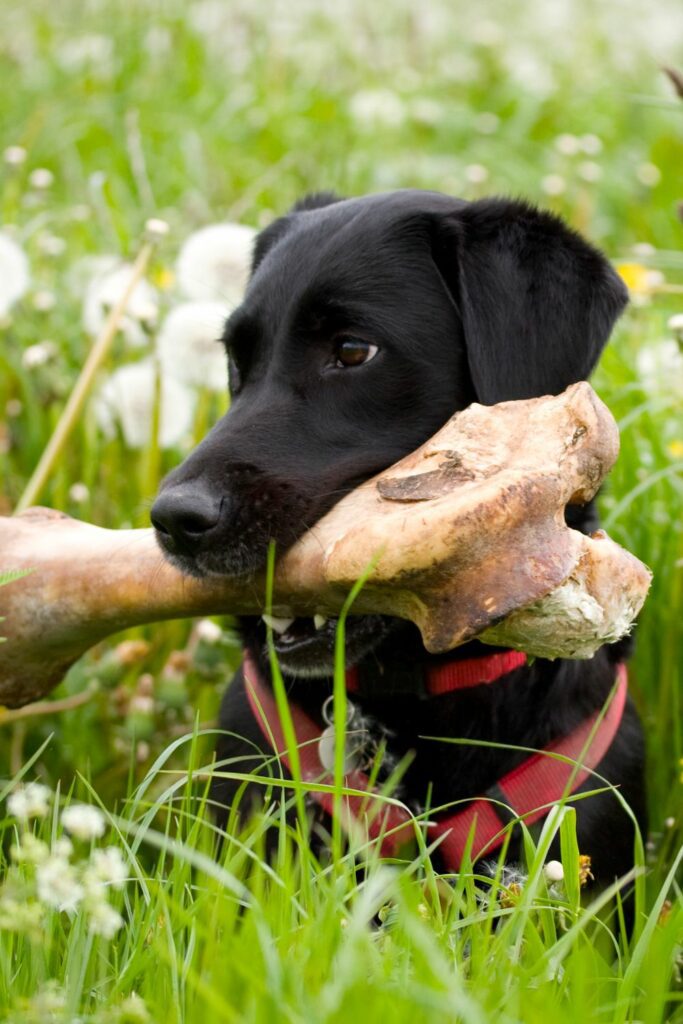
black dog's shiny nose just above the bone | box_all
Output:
[151,484,222,555]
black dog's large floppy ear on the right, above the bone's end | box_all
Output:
[433,199,628,404]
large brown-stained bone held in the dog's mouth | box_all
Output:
[0,383,650,706]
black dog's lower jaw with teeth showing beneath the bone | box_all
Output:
[263,615,399,679]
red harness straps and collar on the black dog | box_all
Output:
[244,651,628,871]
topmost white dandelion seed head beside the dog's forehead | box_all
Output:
[175,223,257,305]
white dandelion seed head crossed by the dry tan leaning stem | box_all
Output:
[83,257,159,348]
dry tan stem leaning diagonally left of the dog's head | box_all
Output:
[14,238,157,515]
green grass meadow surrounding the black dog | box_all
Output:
[0,0,683,1024]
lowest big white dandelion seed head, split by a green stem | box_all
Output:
[94,359,196,449]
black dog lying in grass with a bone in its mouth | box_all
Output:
[152,190,645,883]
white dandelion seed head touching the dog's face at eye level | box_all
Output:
[157,302,229,391]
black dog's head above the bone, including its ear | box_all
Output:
[152,190,626,671]
